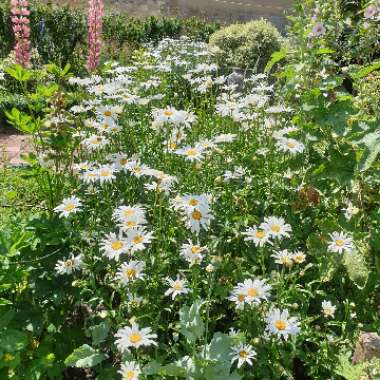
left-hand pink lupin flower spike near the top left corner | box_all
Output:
[11,0,31,67]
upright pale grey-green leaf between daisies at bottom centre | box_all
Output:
[179,300,204,342]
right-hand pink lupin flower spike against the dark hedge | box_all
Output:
[86,0,104,71]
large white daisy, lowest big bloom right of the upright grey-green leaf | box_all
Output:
[266,308,300,340]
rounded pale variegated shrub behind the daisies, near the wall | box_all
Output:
[209,20,282,71]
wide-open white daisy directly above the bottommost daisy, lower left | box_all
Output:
[115,323,157,352]
